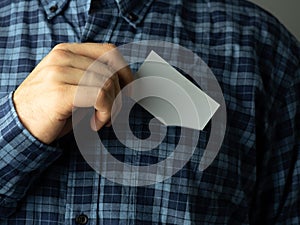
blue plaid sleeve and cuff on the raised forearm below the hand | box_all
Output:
[0,93,61,218]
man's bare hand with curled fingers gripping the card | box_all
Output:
[13,43,133,144]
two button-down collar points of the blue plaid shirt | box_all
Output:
[40,0,154,27]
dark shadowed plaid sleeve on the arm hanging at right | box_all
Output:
[251,33,300,225]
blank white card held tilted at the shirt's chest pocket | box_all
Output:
[133,51,220,130]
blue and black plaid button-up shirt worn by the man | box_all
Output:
[0,0,300,225]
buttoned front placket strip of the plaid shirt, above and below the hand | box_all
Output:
[65,0,119,225]
